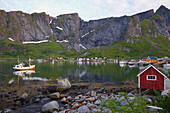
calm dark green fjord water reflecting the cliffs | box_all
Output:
[0,60,139,84]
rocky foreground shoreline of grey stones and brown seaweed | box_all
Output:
[0,81,137,113]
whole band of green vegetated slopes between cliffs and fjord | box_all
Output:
[0,35,170,59]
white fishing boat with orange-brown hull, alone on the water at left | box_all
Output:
[13,58,35,71]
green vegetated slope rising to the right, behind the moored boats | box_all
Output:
[76,36,170,59]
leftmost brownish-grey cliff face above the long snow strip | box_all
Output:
[0,10,52,41]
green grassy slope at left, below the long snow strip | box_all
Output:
[0,39,74,58]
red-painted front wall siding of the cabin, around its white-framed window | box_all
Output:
[140,67,164,90]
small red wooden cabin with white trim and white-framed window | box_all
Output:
[137,65,168,90]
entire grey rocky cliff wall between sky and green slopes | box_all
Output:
[0,6,170,51]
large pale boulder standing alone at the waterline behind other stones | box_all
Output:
[57,78,71,91]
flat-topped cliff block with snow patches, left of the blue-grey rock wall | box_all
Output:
[50,13,81,51]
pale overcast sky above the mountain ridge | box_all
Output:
[0,0,170,21]
